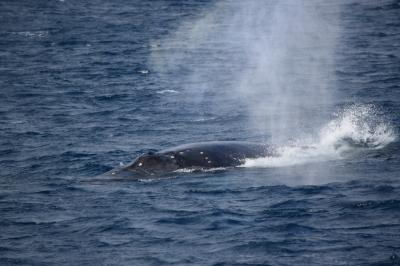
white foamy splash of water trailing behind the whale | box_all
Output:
[242,104,396,167]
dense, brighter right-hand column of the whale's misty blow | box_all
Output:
[236,1,340,144]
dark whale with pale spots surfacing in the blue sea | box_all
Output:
[104,141,275,178]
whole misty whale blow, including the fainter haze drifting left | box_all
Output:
[149,0,341,143]
